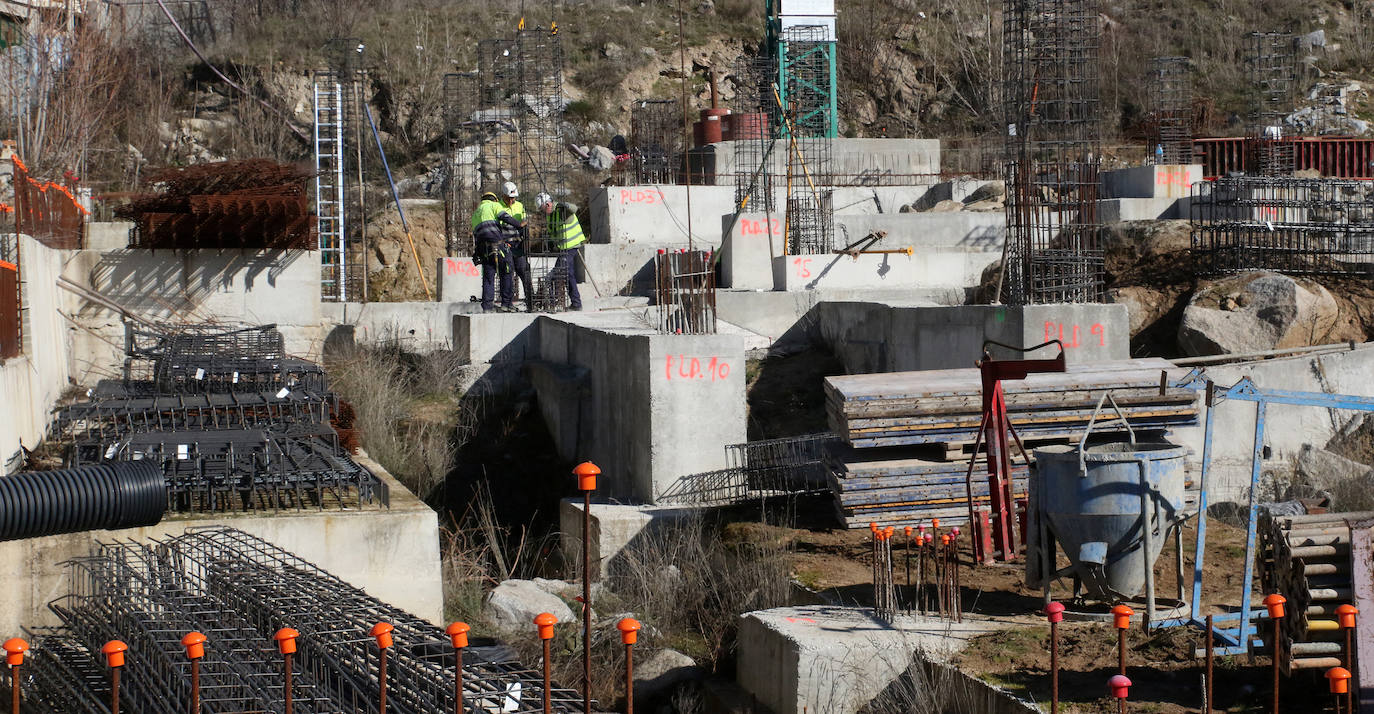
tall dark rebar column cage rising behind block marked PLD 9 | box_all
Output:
[1000,0,1105,305]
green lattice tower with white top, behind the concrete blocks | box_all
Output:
[765,0,840,139]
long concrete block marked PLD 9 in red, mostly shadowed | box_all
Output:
[816,302,1131,373]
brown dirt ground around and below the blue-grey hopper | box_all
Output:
[731,505,1327,714]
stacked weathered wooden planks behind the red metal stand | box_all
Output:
[826,360,1198,527]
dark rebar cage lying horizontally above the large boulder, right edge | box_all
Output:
[1190,176,1374,276]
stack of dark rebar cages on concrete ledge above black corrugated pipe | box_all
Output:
[51,325,390,511]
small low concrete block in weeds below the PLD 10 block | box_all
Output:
[558,498,698,579]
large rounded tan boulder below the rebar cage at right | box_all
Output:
[1179,272,1340,356]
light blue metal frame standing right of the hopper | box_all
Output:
[1160,369,1374,655]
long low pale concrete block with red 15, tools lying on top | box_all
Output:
[774,250,1000,291]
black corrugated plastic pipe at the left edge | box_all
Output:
[0,461,168,541]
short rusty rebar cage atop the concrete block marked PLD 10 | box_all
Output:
[654,250,716,335]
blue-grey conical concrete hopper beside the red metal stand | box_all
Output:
[1028,442,1187,601]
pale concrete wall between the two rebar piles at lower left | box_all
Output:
[0,461,444,632]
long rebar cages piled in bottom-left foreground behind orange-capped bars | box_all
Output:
[25,527,581,714]
